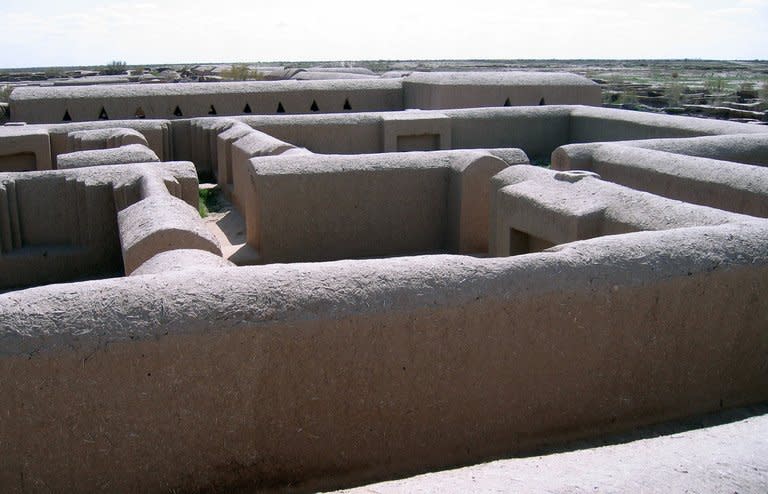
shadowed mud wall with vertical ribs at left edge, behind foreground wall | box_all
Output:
[0,162,197,290]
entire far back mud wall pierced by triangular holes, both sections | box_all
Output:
[10,72,601,123]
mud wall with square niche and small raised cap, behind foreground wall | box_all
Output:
[489,166,754,256]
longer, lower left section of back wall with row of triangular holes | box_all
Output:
[10,79,403,123]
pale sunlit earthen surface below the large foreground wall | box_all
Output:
[332,407,768,494]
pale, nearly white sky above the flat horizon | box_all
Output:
[0,0,768,67]
